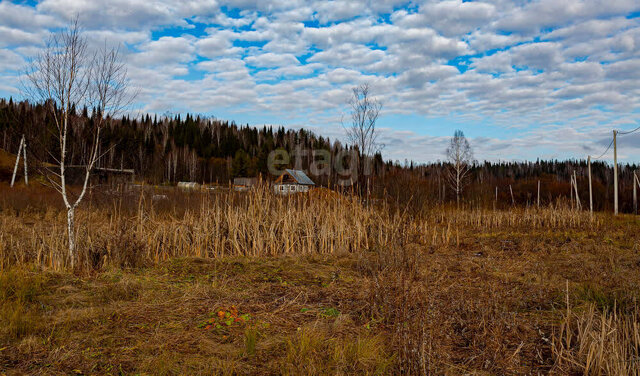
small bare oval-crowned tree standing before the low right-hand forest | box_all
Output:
[446,130,473,205]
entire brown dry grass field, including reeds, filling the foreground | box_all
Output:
[0,181,640,375]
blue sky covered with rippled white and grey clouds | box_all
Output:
[0,0,640,161]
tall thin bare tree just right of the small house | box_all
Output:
[343,83,382,189]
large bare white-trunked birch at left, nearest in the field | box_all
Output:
[24,17,133,267]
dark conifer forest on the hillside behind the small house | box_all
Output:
[0,98,383,184]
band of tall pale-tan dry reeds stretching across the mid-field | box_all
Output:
[0,183,599,270]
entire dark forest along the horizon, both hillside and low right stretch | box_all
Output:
[0,99,638,212]
